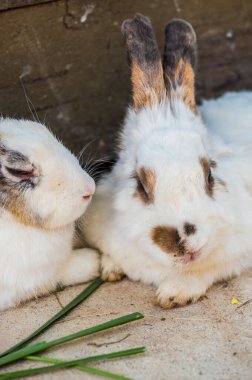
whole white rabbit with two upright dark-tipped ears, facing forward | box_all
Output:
[82,15,252,308]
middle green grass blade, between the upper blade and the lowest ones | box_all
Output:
[0,313,144,366]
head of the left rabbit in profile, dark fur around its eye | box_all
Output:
[0,119,95,229]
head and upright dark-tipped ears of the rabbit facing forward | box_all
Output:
[114,15,225,265]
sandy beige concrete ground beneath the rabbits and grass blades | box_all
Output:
[0,272,252,380]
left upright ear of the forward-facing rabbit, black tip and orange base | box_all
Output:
[122,14,165,111]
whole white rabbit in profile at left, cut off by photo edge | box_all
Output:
[0,118,99,310]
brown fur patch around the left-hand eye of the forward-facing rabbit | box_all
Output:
[133,167,156,204]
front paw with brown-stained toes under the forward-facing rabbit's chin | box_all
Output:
[155,277,207,309]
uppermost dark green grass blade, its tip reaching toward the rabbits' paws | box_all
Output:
[0,278,103,358]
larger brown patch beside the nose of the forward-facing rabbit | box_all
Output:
[151,226,185,256]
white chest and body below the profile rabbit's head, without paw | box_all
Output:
[0,213,73,308]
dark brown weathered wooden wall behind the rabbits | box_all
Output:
[0,0,252,157]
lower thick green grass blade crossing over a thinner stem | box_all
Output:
[0,347,145,380]
